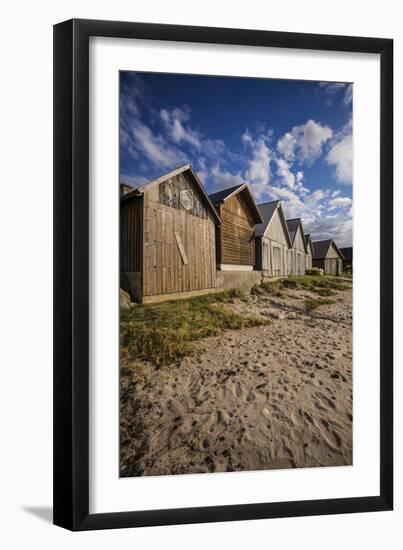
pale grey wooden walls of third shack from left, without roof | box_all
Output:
[256,210,289,277]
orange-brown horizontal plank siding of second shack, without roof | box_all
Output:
[217,193,255,266]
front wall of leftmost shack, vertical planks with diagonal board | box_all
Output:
[143,173,216,296]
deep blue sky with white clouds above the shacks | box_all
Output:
[120,72,353,246]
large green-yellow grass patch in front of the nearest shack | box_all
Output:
[120,290,268,365]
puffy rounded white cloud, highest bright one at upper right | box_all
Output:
[277,120,333,165]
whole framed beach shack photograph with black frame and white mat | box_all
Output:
[54,20,393,530]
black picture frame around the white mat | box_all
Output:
[54,19,393,531]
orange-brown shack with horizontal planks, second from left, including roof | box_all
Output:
[210,183,263,271]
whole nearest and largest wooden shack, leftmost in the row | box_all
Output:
[120,164,220,302]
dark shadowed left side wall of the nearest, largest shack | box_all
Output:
[120,196,143,272]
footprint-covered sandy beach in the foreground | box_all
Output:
[121,289,352,476]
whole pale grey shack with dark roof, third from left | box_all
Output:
[255,201,292,277]
